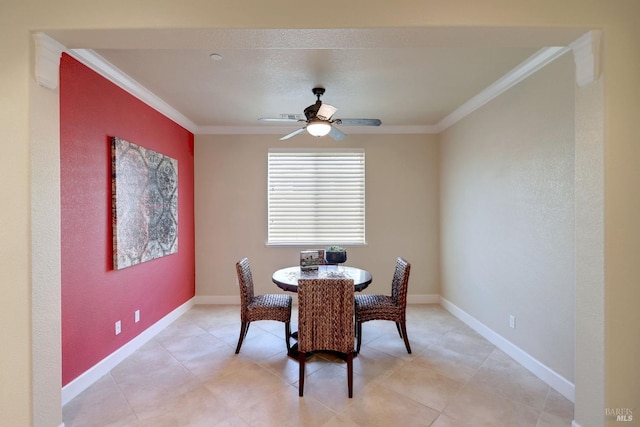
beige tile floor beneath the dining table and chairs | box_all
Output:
[63,305,573,427]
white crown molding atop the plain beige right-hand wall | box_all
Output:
[435,46,569,133]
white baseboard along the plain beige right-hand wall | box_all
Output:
[440,298,577,404]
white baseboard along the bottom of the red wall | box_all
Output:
[62,298,195,406]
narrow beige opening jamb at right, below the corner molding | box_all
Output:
[575,64,604,426]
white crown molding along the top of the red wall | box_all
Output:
[68,49,198,133]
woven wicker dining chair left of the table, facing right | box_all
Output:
[236,258,292,354]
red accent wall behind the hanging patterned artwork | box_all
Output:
[60,55,195,386]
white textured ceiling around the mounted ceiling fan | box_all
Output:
[47,28,584,134]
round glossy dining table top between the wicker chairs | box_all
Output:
[271,265,373,292]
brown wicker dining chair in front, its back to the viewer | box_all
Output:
[297,279,355,397]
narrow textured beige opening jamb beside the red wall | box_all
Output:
[30,76,62,425]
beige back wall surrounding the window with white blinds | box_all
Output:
[195,134,439,302]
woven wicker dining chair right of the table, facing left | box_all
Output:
[355,258,411,354]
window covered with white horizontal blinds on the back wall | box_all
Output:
[267,149,365,246]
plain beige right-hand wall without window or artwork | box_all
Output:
[441,54,575,382]
